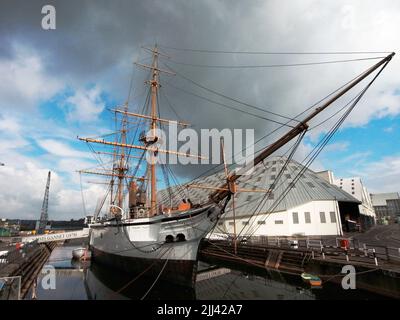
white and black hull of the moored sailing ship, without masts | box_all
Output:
[90,206,220,286]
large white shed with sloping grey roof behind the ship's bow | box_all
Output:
[159,157,360,236]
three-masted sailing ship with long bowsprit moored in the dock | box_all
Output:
[79,46,394,287]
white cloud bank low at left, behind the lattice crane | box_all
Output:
[0,162,104,220]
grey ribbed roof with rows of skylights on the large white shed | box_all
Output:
[159,156,360,215]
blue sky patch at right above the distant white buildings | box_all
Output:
[308,116,400,193]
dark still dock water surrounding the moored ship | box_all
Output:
[27,246,394,300]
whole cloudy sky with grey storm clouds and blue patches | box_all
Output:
[0,0,400,219]
